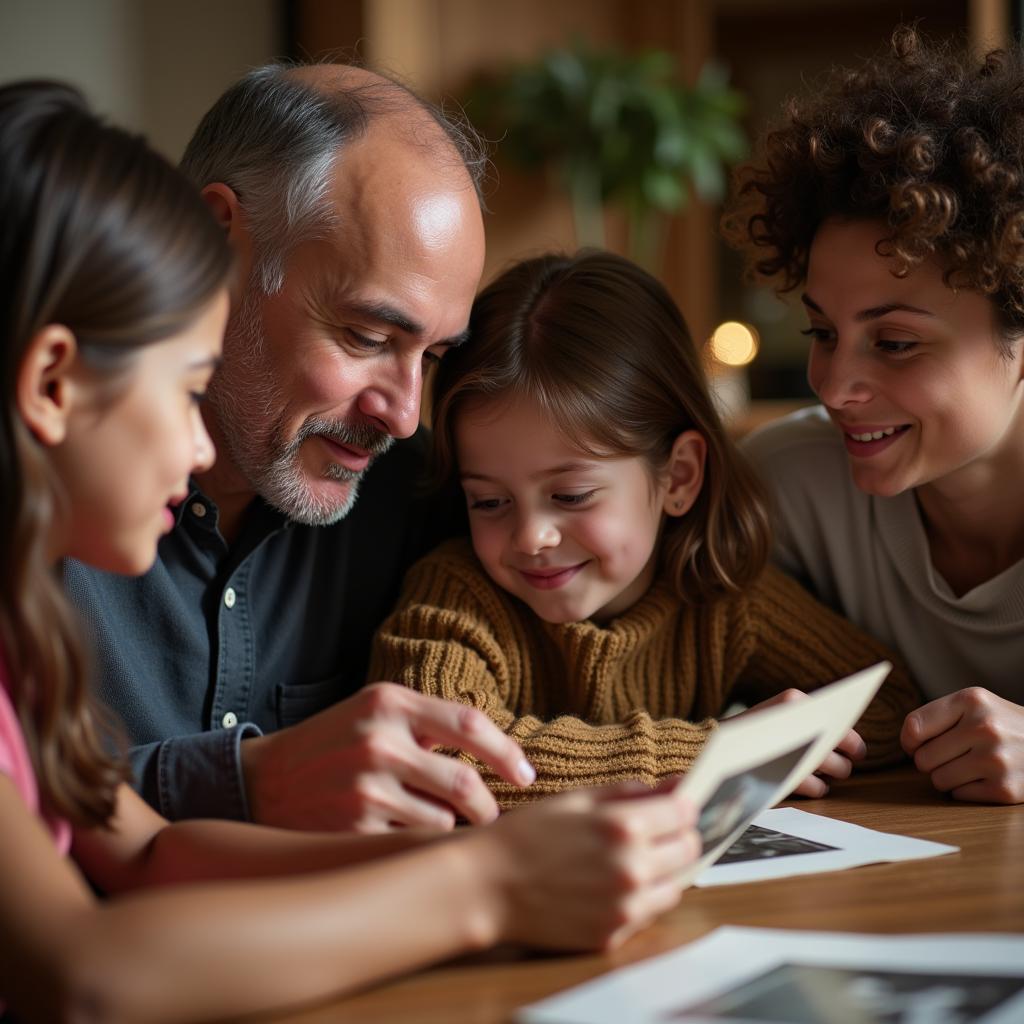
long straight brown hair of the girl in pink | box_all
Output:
[0,82,230,825]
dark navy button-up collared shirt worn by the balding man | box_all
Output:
[65,436,452,819]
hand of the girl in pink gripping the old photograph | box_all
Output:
[465,783,700,949]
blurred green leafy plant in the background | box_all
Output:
[467,44,746,268]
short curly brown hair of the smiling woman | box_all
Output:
[723,26,1024,337]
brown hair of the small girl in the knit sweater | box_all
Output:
[433,251,770,602]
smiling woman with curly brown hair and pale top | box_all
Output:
[724,28,1024,803]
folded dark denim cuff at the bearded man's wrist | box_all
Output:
[128,722,262,821]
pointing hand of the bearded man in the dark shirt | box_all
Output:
[235,683,534,833]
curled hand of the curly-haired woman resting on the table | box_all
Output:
[900,686,1024,804]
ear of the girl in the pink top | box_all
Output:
[15,324,78,446]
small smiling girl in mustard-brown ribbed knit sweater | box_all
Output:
[370,252,920,806]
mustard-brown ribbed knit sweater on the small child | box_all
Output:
[370,541,922,807]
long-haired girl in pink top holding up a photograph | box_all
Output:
[0,83,697,1024]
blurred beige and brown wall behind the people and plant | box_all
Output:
[0,0,1024,425]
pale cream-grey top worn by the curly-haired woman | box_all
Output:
[743,406,1024,705]
